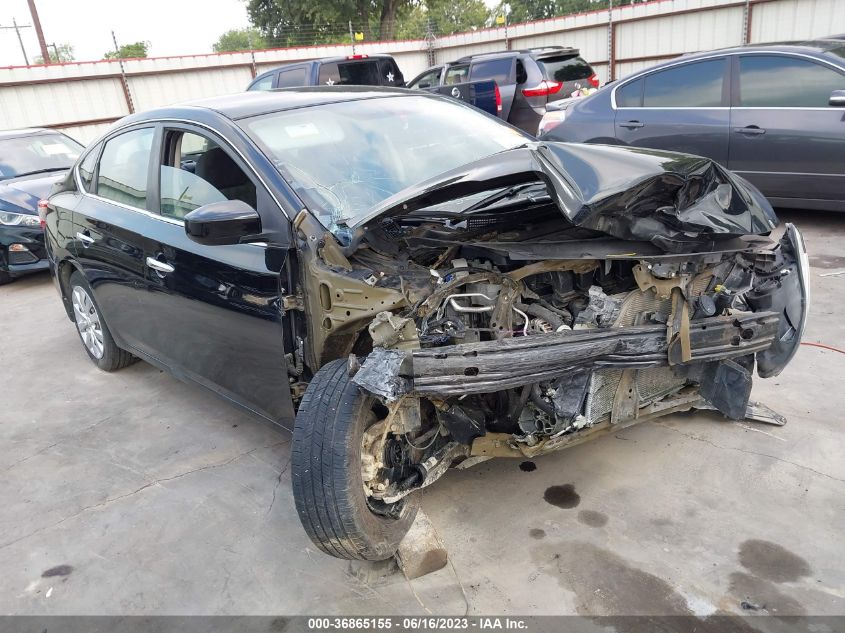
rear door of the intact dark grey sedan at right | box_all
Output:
[611,57,730,165]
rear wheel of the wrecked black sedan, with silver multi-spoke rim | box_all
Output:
[68,272,138,372]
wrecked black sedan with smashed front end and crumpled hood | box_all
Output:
[46,88,808,560]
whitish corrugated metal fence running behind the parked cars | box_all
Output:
[0,0,845,142]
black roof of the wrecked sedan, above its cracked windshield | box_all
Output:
[114,86,422,126]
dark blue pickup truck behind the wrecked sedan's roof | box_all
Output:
[247,55,502,116]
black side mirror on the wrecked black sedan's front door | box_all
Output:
[185,200,261,246]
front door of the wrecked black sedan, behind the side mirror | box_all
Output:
[144,125,293,423]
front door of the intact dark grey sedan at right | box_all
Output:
[728,53,845,208]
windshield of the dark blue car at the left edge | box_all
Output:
[0,132,82,180]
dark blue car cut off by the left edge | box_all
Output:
[0,128,82,284]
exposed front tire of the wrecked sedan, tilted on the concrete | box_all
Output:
[291,360,418,560]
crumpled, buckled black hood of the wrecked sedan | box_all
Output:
[355,142,778,252]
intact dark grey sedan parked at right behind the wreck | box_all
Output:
[540,40,845,211]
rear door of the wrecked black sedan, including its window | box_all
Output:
[69,124,156,354]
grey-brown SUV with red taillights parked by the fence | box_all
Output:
[408,46,599,134]
